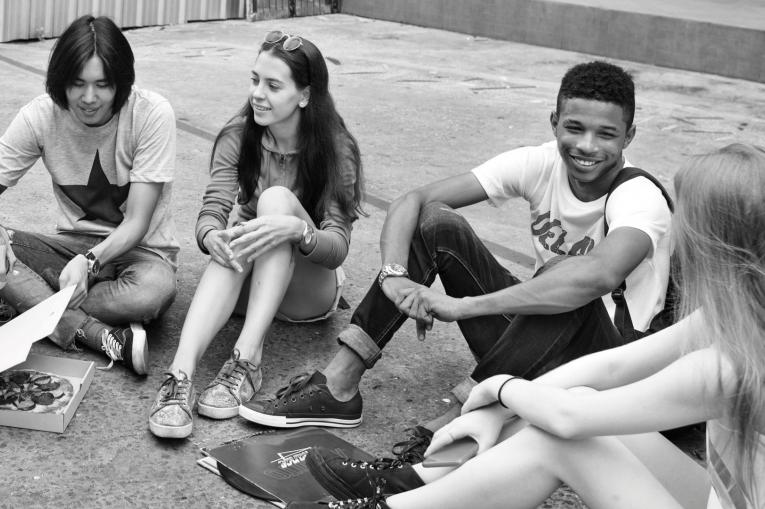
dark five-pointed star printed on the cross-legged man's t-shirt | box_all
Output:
[56,150,130,226]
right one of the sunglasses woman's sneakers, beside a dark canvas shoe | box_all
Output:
[197,348,263,419]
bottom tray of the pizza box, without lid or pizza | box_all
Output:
[0,353,95,433]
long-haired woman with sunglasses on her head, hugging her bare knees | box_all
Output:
[149,32,362,438]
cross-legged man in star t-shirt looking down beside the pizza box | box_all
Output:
[0,16,179,374]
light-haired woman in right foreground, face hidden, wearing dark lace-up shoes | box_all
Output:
[287,144,765,509]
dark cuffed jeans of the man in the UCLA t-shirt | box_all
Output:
[338,203,625,382]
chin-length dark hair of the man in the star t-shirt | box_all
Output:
[45,14,135,113]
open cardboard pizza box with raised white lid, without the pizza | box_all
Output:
[0,286,95,433]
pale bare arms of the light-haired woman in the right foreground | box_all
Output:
[431,311,711,450]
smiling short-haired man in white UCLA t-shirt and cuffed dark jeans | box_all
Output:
[240,62,670,444]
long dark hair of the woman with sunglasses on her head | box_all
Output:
[210,39,364,225]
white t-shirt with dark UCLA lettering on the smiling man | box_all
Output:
[473,141,671,331]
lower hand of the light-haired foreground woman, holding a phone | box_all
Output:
[425,406,507,457]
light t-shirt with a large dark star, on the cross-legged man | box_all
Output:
[0,88,179,265]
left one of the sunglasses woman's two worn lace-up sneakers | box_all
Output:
[149,371,196,438]
